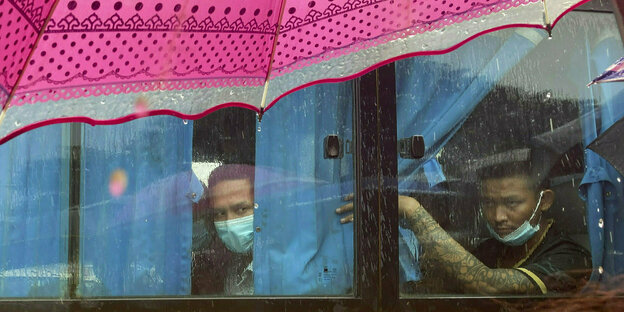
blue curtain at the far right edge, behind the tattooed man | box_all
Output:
[578,33,624,281]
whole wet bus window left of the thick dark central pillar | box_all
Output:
[0,82,354,298]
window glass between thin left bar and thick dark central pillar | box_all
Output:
[77,83,354,297]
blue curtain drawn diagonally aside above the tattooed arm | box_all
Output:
[396,29,545,193]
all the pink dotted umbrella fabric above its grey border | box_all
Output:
[0,0,541,105]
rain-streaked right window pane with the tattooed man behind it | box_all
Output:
[396,12,624,296]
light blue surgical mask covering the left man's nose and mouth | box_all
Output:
[214,214,253,253]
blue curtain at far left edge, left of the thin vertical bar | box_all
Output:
[0,125,69,297]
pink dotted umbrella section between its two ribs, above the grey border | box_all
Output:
[11,0,280,105]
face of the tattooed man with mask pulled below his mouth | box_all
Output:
[481,175,541,237]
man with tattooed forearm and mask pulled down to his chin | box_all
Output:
[338,150,591,295]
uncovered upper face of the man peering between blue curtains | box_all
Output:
[210,179,254,221]
